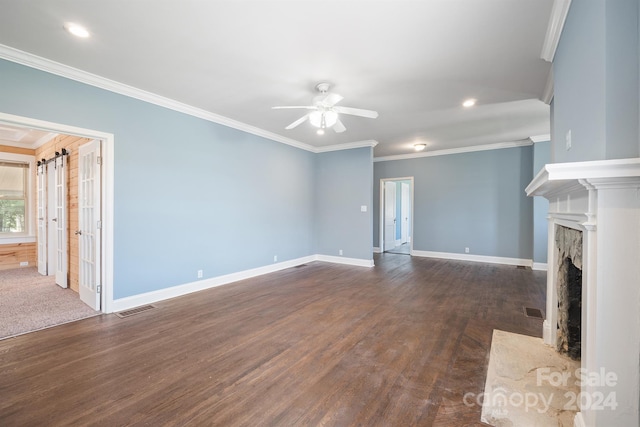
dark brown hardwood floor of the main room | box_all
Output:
[0,254,546,426]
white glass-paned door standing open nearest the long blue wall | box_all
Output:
[76,140,102,310]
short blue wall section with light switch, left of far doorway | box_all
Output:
[315,147,373,260]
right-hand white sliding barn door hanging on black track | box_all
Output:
[52,156,68,288]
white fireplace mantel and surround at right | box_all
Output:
[526,158,640,426]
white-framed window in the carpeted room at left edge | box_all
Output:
[0,153,33,239]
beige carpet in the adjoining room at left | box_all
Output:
[0,267,100,339]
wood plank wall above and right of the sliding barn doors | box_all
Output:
[34,135,90,292]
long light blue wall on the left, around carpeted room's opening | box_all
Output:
[0,60,324,299]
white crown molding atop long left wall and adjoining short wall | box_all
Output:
[0,44,378,153]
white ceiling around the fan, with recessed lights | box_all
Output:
[0,0,553,157]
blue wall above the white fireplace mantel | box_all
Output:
[552,0,640,162]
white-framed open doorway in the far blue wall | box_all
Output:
[380,177,414,255]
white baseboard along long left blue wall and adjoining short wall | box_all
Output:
[109,255,374,313]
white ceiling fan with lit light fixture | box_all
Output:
[273,83,378,135]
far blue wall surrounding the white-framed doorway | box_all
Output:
[373,146,533,259]
